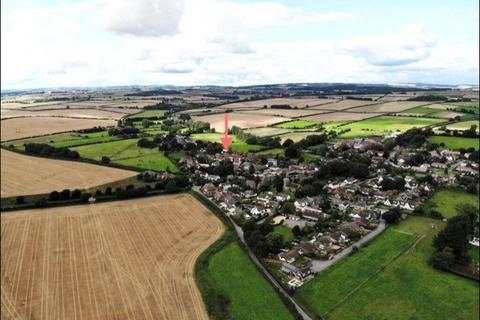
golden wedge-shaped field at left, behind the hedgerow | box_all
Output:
[1,149,137,198]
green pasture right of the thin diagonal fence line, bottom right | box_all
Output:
[326,216,479,320]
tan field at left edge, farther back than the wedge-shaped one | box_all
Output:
[1,117,116,141]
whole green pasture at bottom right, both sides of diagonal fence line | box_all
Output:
[296,217,479,320]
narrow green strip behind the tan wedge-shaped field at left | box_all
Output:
[4,131,119,149]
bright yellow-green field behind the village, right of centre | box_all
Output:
[340,116,442,138]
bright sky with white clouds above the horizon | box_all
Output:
[1,0,479,89]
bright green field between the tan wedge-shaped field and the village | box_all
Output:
[72,139,178,172]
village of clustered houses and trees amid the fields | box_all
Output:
[182,134,479,288]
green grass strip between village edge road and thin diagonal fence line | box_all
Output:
[295,228,417,319]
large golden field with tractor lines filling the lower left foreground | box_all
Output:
[1,194,223,320]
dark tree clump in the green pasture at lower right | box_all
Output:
[433,215,471,265]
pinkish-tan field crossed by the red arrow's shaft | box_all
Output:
[192,113,285,132]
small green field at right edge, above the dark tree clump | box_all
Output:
[424,189,479,218]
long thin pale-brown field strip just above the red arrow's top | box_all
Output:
[217,98,332,111]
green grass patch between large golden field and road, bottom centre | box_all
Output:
[202,242,293,320]
